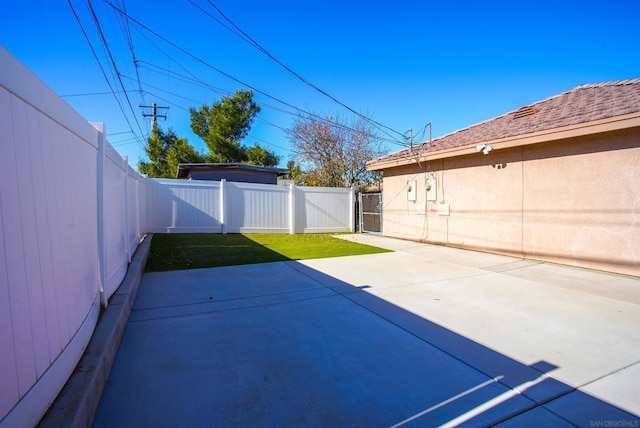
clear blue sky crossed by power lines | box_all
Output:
[0,0,640,166]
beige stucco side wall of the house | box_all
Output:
[383,128,640,276]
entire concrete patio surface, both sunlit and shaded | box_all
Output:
[94,234,640,427]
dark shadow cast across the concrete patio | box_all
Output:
[94,238,638,427]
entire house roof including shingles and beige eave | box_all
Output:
[367,79,640,170]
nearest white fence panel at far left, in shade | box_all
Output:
[0,48,99,426]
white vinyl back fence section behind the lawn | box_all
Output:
[147,179,354,233]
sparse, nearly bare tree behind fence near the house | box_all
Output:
[287,116,382,190]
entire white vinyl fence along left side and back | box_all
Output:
[0,46,354,428]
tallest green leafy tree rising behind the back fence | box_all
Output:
[189,89,279,165]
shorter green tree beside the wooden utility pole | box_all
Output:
[138,125,204,178]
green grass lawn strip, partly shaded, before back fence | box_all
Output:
[145,233,390,272]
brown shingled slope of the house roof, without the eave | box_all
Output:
[369,79,640,169]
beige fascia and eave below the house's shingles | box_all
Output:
[366,112,640,171]
